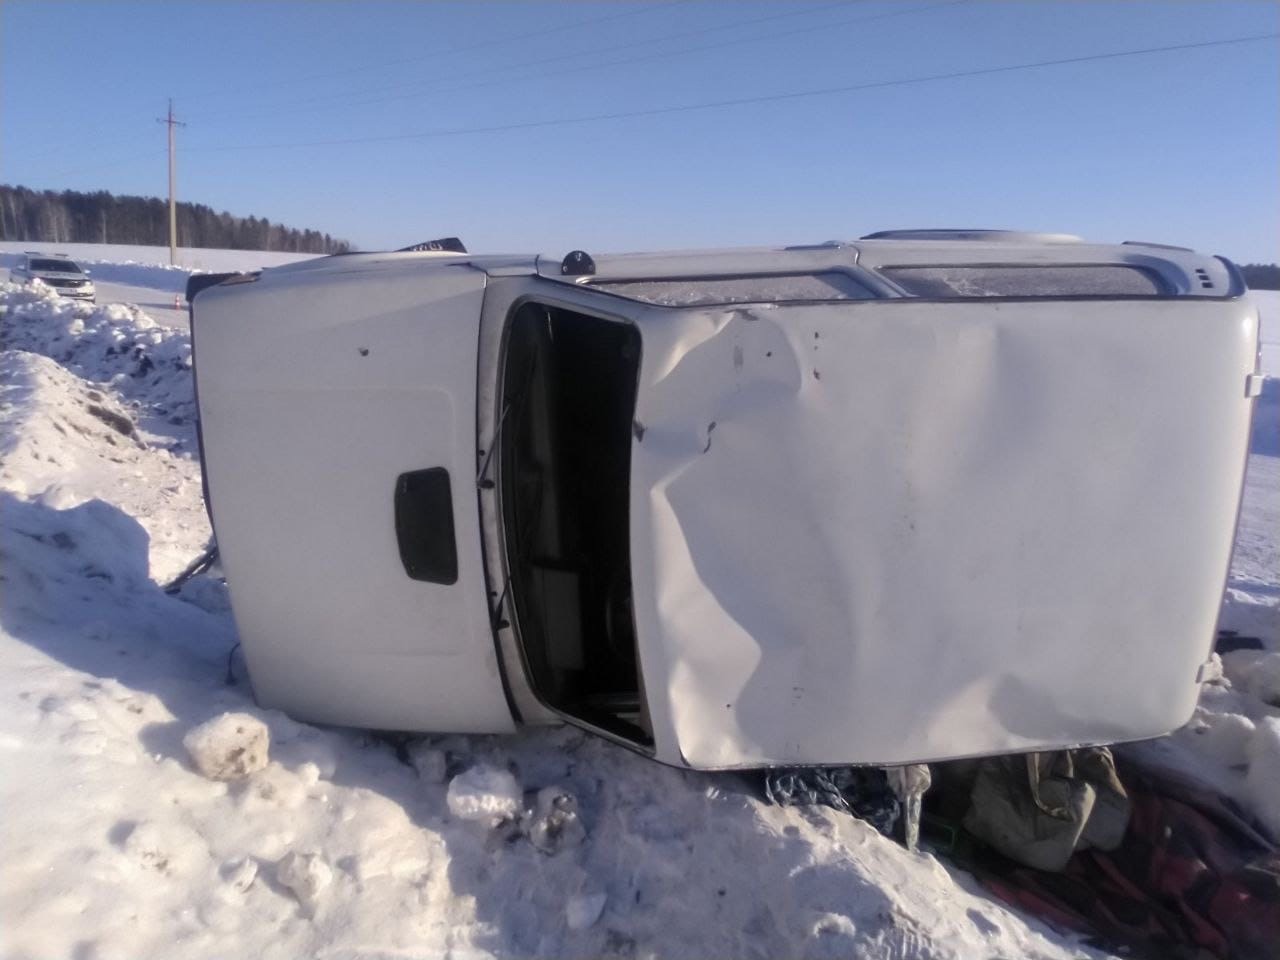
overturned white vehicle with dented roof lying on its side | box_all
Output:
[192,230,1261,769]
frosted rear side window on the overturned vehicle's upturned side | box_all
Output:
[881,264,1167,300]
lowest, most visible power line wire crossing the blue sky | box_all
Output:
[193,33,1280,152]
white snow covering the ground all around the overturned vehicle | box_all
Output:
[0,247,1280,960]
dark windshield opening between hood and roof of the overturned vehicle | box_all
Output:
[498,302,652,745]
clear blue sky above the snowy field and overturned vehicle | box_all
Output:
[0,0,1280,261]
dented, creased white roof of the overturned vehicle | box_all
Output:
[631,298,1257,768]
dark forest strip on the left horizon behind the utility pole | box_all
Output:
[0,184,351,253]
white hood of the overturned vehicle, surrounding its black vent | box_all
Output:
[193,255,515,732]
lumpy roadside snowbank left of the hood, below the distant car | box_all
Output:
[0,283,211,580]
